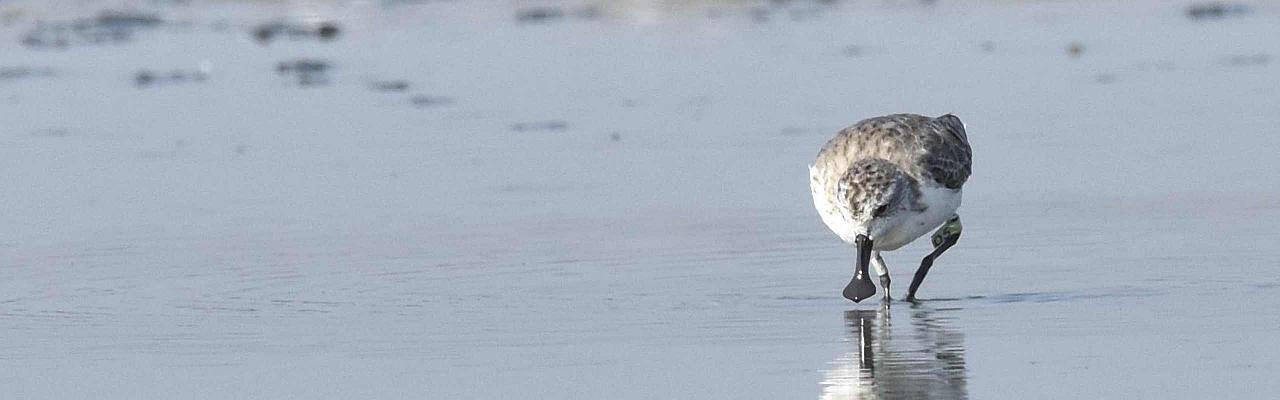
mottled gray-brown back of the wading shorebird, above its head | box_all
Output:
[813,114,970,188]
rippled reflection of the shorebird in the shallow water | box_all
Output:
[820,305,969,399]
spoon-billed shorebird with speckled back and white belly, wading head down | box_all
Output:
[809,114,970,303]
